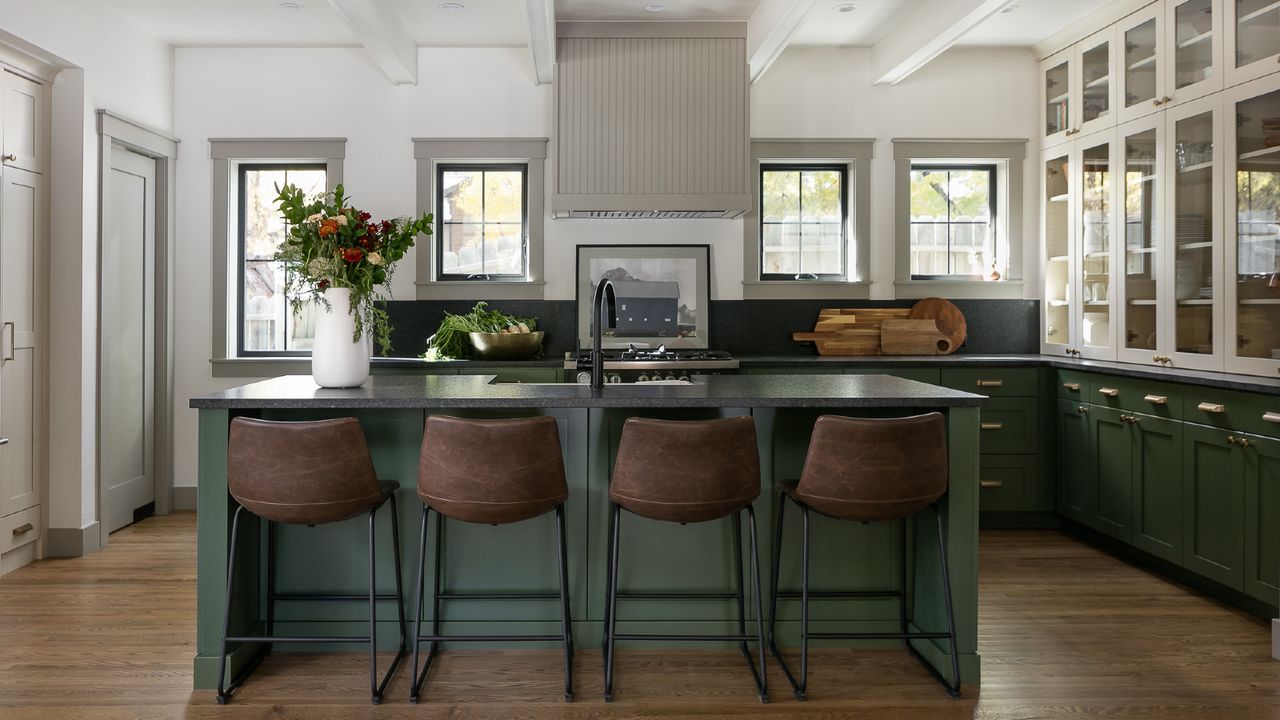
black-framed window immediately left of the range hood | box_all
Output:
[435,163,529,281]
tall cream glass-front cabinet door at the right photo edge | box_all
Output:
[1225,74,1280,377]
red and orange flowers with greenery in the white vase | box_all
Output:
[274,184,431,354]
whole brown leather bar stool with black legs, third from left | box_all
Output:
[604,416,769,702]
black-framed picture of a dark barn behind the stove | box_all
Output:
[577,245,710,350]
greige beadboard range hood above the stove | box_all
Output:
[550,22,751,219]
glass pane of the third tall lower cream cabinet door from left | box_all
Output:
[1126,129,1160,350]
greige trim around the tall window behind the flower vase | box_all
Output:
[209,137,347,363]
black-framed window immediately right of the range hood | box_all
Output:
[760,164,849,281]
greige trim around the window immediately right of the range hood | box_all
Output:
[742,138,876,300]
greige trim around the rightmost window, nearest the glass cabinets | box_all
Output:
[893,138,1027,299]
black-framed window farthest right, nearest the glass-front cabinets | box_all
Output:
[910,163,998,279]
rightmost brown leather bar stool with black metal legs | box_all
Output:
[769,413,960,700]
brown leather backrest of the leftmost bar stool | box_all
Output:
[227,418,385,525]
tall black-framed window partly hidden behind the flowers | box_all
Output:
[236,163,328,356]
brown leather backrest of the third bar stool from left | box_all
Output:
[609,416,760,523]
